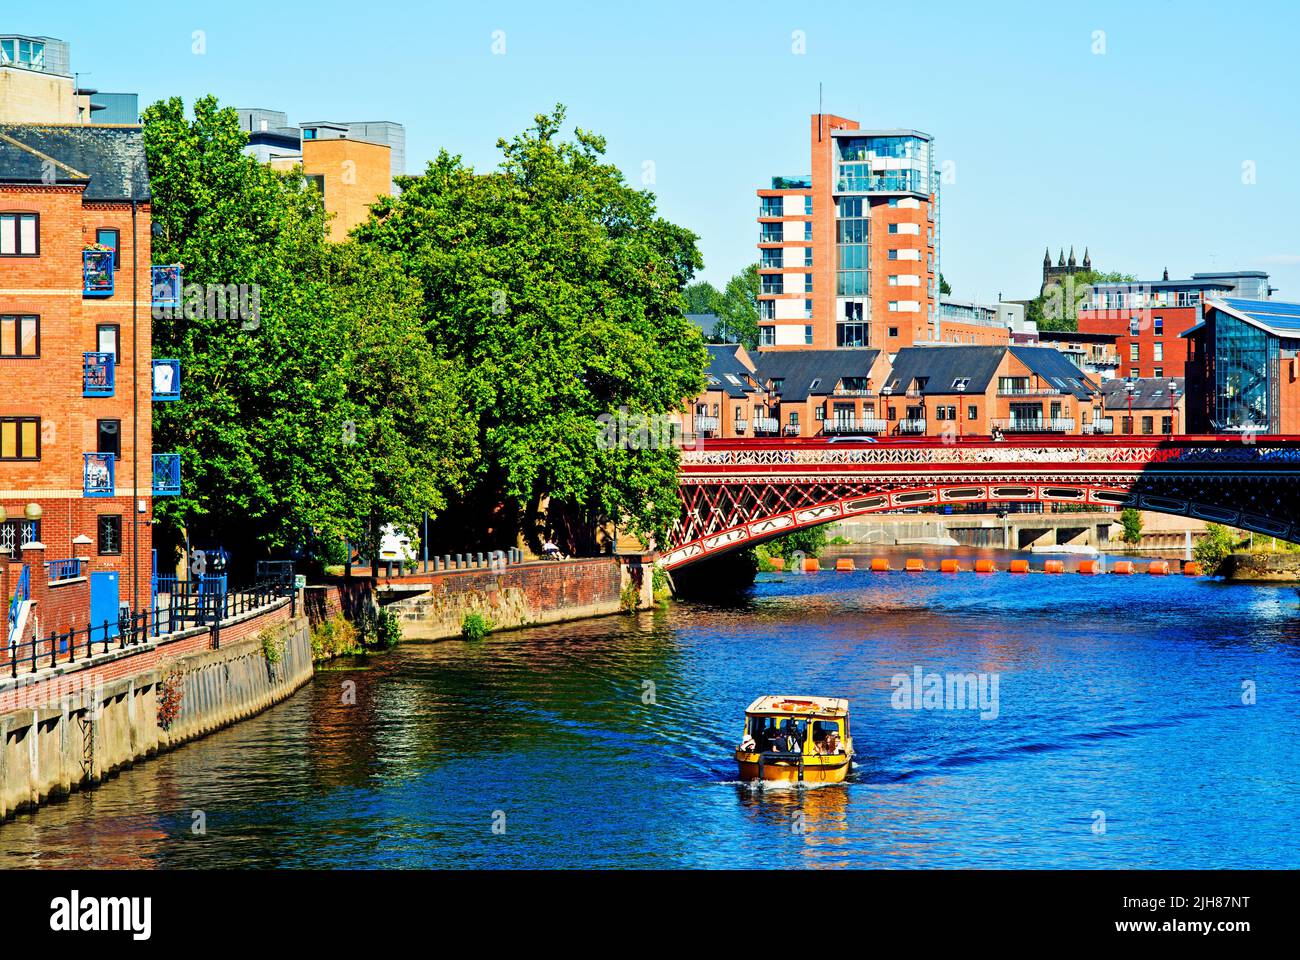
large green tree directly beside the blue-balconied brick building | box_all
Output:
[144,96,469,572]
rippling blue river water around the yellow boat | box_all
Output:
[0,546,1300,868]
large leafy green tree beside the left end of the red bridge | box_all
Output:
[354,107,707,548]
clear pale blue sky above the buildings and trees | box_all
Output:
[17,0,1300,299]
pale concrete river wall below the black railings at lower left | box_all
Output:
[0,600,312,821]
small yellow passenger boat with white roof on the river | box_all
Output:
[736,696,853,783]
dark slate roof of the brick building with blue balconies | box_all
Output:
[0,124,150,200]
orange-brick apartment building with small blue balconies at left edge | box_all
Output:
[0,124,179,632]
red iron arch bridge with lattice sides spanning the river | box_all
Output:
[663,434,1300,570]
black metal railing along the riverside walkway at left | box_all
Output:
[0,579,298,676]
